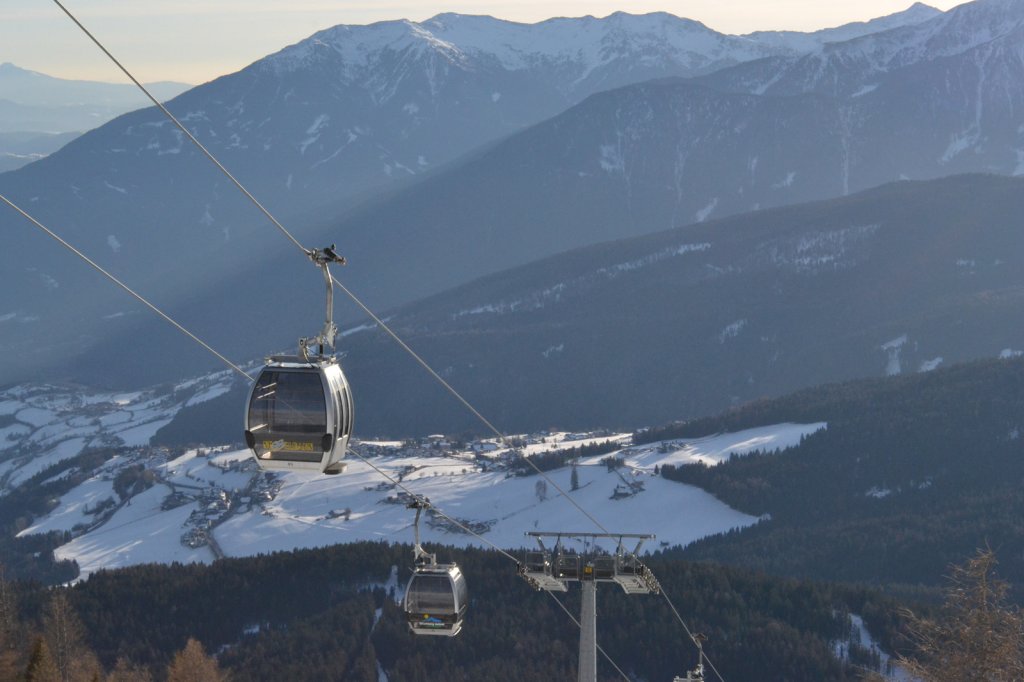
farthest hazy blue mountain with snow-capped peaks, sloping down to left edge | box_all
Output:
[0,6,942,379]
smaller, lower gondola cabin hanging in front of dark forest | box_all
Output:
[402,564,469,637]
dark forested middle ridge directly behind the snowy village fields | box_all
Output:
[315,175,1024,433]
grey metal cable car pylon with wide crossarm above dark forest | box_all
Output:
[519,531,662,682]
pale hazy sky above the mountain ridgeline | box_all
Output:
[0,0,962,84]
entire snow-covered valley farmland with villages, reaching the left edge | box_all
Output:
[0,374,826,577]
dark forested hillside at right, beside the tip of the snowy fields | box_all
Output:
[637,359,1024,585]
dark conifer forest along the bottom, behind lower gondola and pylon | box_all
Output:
[0,544,894,682]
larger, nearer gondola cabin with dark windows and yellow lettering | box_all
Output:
[245,356,352,474]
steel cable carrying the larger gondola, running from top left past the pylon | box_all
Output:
[53,5,725,682]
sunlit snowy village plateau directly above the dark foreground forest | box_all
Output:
[25,424,822,576]
